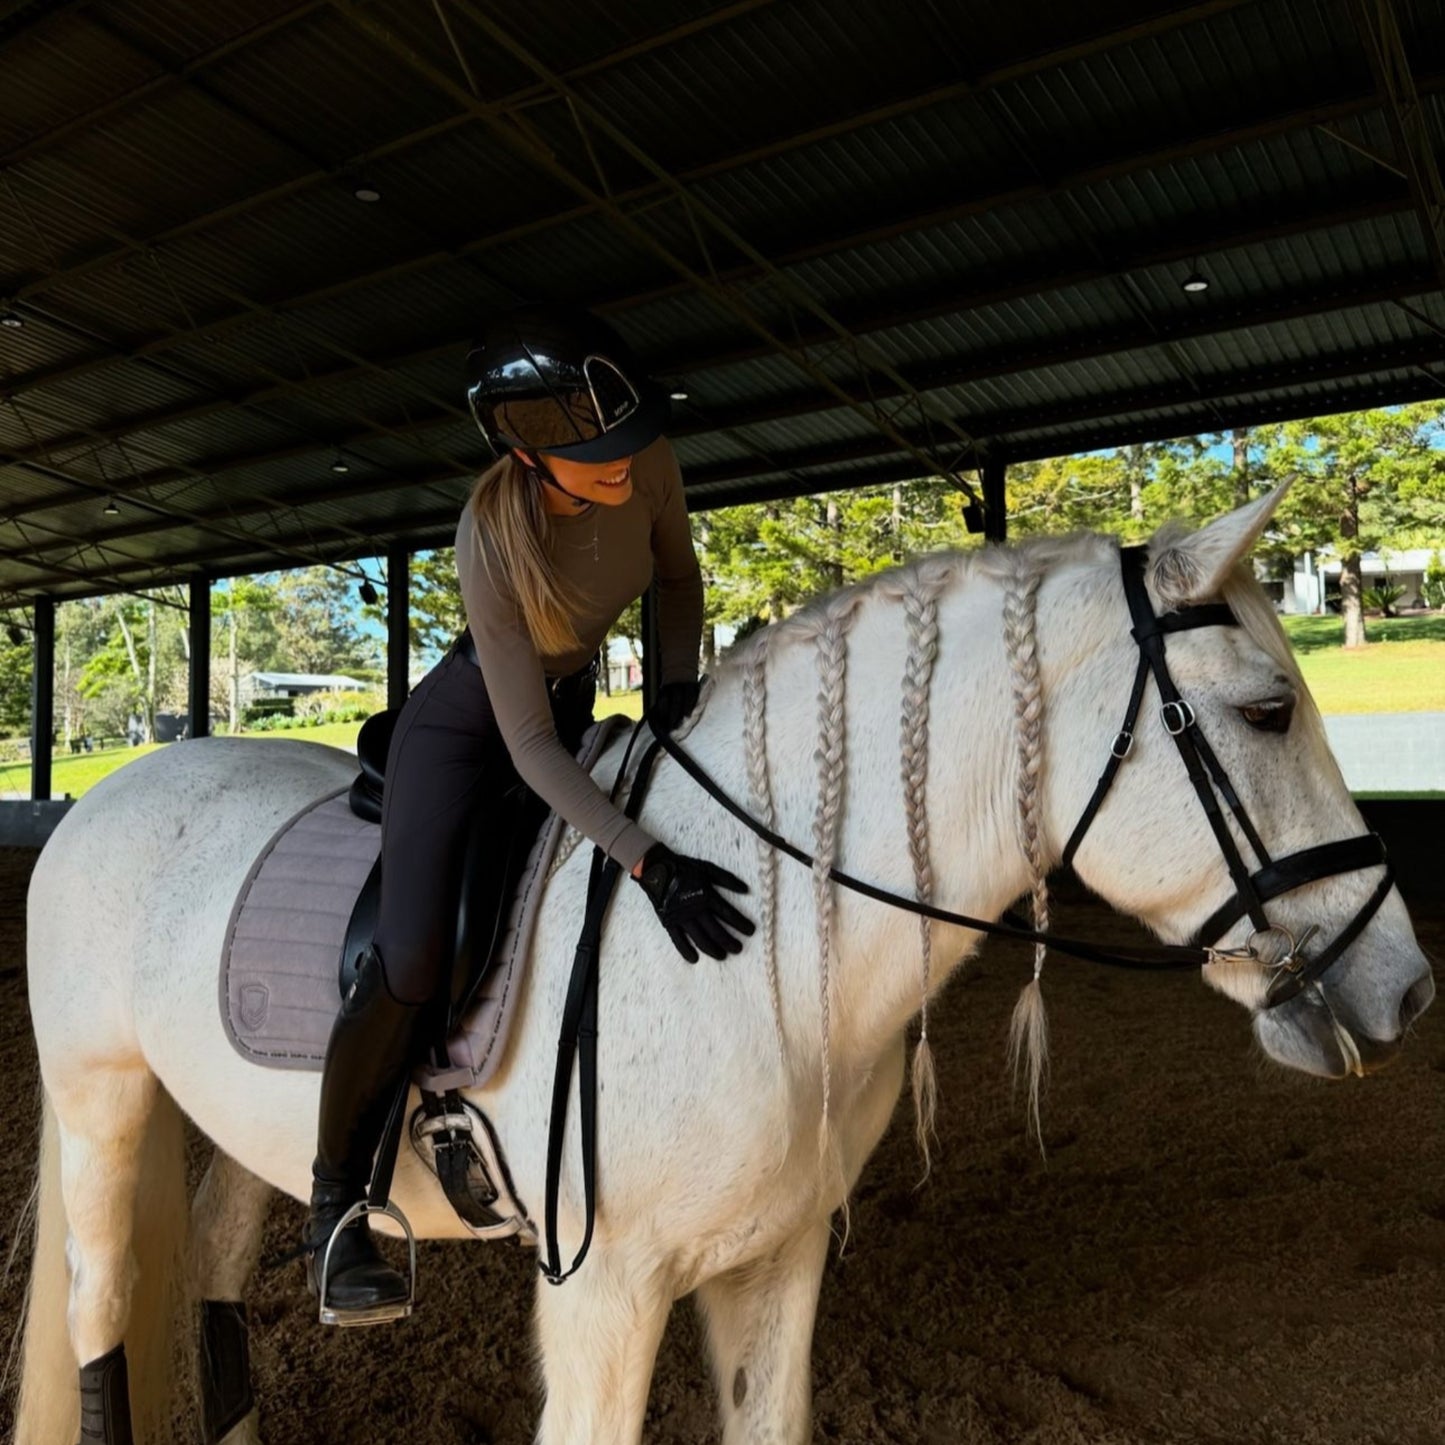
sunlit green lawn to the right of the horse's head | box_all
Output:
[1285,616,1445,712]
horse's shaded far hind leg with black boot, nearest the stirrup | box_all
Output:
[191,1149,272,1445]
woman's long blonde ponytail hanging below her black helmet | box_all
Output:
[471,454,582,657]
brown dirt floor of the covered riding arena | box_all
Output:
[0,850,1445,1445]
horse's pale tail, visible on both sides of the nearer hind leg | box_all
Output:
[14,1090,191,1445]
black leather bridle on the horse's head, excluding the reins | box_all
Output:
[1062,546,1394,1009]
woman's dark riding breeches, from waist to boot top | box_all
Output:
[373,637,592,1003]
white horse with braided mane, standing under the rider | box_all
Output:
[17,497,1433,1445]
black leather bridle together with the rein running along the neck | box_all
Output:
[657,546,1394,1009]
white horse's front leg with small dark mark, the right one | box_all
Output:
[698,1217,829,1445]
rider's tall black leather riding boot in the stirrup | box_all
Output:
[305,948,425,1324]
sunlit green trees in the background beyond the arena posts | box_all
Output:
[0,402,1445,740]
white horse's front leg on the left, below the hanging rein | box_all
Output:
[536,1250,673,1445]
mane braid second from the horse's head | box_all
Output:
[899,568,946,1178]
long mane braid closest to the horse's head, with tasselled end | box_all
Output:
[1003,555,1049,1150]
